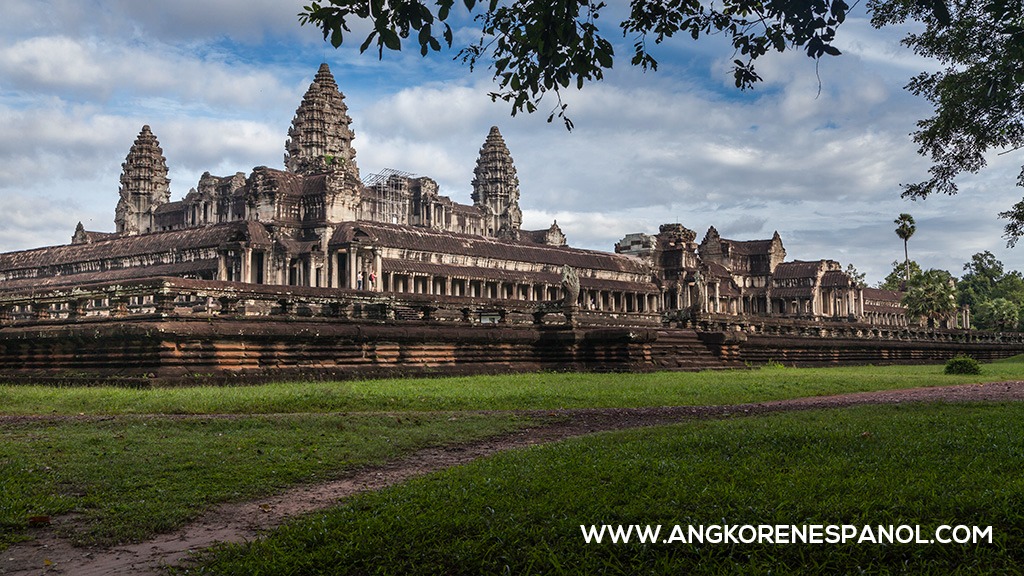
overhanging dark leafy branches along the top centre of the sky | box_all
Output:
[299,0,880,128]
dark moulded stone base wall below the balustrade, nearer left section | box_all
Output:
[0,318,654,384]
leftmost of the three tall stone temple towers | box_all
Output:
[114,125,171,236]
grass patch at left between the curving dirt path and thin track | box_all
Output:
[0,414,528,549]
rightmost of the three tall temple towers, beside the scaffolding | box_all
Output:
[472,126,522,238]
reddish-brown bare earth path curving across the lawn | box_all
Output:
[6,381,1024,576]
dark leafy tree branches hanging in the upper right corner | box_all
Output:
[868,0,1024,245]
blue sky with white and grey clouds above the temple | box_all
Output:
[0,0,1024,284]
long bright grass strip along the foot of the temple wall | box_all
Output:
[0,357,1024,414]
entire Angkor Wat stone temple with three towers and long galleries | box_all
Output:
[0,64,1009,375]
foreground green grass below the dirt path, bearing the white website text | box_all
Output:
[188,404,1024,576]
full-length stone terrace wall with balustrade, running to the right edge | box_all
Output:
[0,279,1024,385]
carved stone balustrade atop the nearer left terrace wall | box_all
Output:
[0,278,660,328]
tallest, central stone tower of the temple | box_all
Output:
[285,63,358,178]
